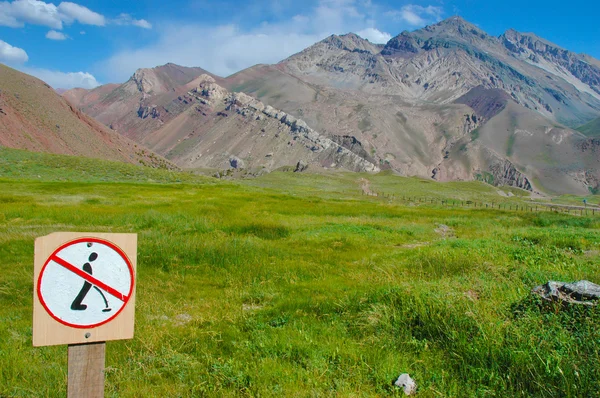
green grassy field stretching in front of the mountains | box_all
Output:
[0,150,600,397]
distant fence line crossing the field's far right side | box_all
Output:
[361,190,600,216]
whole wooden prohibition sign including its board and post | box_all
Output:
[33,232,137,398]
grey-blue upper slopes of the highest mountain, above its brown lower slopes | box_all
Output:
[281,17,600,127]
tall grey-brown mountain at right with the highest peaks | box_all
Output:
[225,17,600,193]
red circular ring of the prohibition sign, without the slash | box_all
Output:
[36,238,135,329]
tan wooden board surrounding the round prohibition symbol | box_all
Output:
[33,232,137,347]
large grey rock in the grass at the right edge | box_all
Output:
[531,280,600,306]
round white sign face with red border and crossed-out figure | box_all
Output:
[37,238,134,328]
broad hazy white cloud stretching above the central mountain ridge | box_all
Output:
[98,0,398,81]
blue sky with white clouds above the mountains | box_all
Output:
[0,0,600,88]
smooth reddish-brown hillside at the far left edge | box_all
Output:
[0,64,174,167]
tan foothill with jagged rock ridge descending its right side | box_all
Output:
[142,75,379,172]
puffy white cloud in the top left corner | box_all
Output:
[0,0,105,30]
